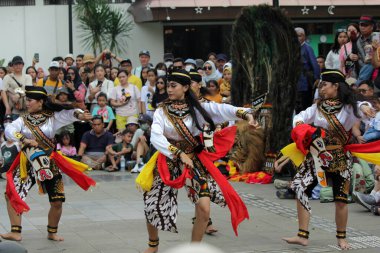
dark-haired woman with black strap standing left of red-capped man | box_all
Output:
[339,23,360,79]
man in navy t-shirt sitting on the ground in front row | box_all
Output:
[78,115,114,170]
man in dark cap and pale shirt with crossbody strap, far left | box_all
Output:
[1,56,33,119]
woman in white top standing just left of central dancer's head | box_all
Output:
[140,69,157,117]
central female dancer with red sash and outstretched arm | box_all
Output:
[144,70,258,253]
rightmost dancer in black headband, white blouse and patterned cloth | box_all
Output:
[283,69,374,250]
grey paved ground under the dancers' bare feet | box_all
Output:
[0,172,380,253]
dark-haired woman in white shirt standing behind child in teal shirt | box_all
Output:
[86,65,114,107]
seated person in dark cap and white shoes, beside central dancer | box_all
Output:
[130,114,153,173]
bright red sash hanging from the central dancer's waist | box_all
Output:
[157,126,249,235]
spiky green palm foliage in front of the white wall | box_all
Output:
[75,0,133,54]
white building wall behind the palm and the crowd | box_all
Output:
[0,0,164,68]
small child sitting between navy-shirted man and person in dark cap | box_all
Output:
[106,129,133,172]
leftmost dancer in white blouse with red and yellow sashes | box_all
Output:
[0,86,96,241]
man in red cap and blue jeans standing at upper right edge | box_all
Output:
[356,15,375,84]
